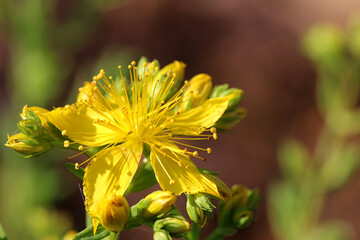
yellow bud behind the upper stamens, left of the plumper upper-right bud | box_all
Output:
[150,61,186,101]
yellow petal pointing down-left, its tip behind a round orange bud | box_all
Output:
[83,142,142,218]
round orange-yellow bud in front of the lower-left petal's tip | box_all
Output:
[99,195,129,232]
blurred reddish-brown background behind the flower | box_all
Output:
[0,0,360,240]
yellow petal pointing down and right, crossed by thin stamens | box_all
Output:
[150,146,223,199]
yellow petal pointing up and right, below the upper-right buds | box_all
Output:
[169,95,232,135]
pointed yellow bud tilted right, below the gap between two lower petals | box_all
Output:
[143,191,176,218]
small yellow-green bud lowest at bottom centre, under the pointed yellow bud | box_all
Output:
[161,217,191,237]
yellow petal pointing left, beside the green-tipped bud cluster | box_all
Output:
[46,104,125,146]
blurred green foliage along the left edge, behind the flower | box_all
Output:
[0,0,134,240]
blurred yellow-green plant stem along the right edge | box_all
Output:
[268,18,360,240]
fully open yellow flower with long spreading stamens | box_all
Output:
[46,59,233,231]
